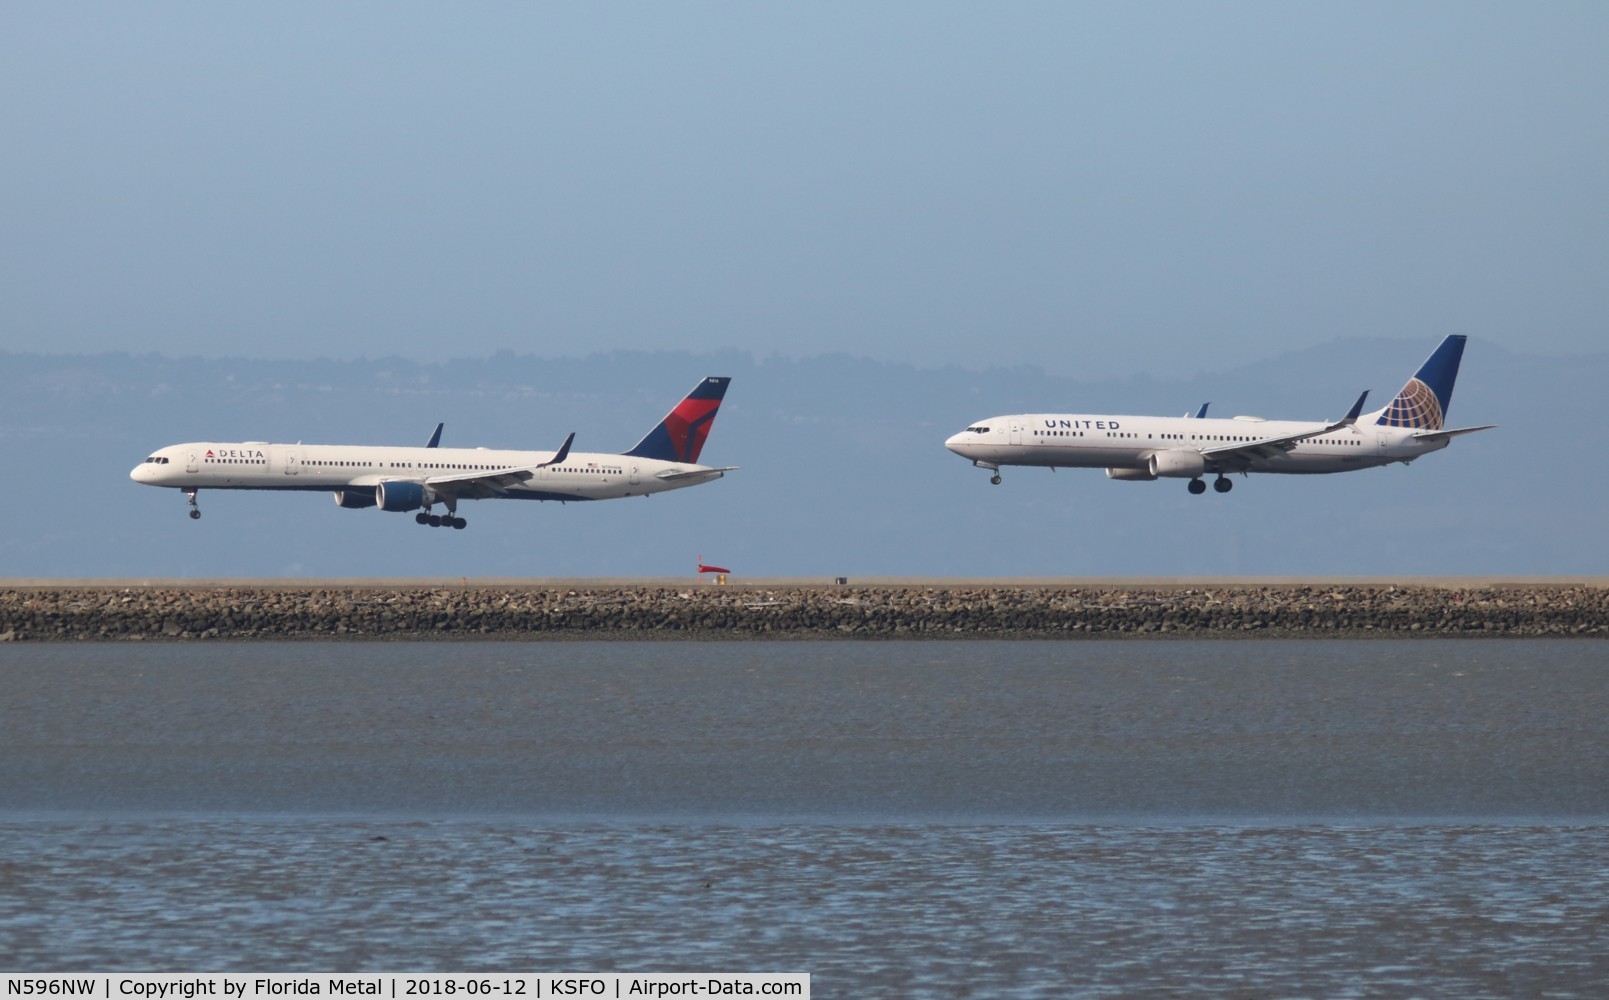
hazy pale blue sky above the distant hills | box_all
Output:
[0,0,1609,376]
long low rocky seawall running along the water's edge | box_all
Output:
[0,584,1609,641]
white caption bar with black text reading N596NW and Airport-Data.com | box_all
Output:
[0,973,809,1000]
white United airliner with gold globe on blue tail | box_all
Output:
[944,336,1496,494]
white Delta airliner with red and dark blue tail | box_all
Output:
[129,378,735,527]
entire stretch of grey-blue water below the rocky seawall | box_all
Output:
[0,640,1609,997]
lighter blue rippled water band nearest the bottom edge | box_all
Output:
[0,818,1609,997]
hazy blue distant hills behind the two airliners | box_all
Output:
[0,338,1609,577]
